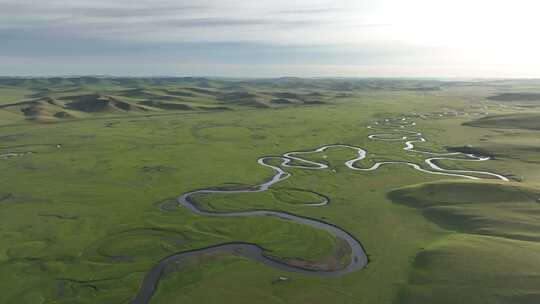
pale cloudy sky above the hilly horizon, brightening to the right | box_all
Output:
[0,0,540,78]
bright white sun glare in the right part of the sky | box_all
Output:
[383,0,540,66]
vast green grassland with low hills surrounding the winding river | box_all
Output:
[0,77,540,304]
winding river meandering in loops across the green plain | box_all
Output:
[132,118,508,304]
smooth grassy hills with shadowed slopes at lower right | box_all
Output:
[390,182,540,303]
